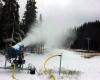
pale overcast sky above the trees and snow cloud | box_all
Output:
[19,0,100,26]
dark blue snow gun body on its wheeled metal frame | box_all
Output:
[0,46,36,74]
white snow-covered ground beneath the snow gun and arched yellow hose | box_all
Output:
[0,49,100,80]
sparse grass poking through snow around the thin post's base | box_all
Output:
[43,68,81,80]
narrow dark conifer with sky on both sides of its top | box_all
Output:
[21,0,37,33]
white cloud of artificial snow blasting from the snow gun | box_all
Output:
[21,21,73,48]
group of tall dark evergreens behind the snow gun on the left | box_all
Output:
[0,0,37,49]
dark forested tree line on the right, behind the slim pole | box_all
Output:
[71,20,100,51]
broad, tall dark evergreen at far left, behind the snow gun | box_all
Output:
[1,0,20,47]
